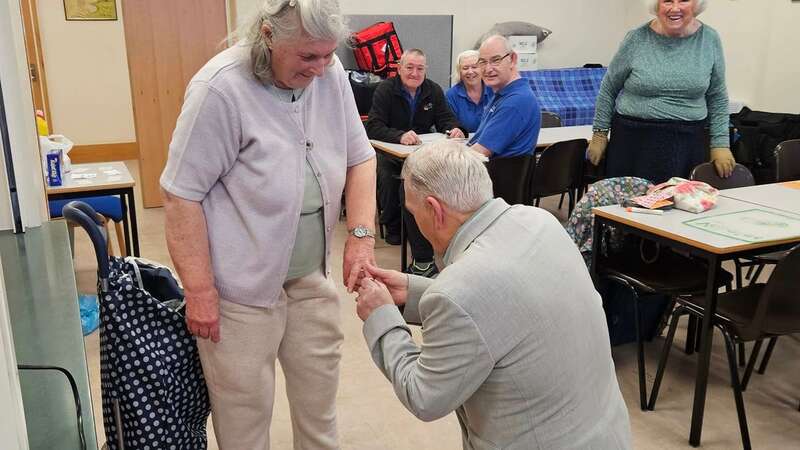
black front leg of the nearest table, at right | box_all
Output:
[689,255,720,447]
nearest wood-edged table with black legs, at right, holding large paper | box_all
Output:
[592,198,800,446]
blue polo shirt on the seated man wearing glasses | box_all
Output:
[468,78,542,158]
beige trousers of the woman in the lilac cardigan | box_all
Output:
[197,270,344,450]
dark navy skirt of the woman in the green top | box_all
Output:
[605,114,708,184]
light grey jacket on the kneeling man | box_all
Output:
[363,199,631,450]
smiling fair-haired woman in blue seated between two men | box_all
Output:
[445,50,494,133]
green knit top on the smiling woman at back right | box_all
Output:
[594,23,730,148]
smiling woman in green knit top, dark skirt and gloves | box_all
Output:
[589,0,736,183]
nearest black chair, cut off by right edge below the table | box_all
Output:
[648,246,800,448]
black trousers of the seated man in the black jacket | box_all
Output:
[378,152,433,262]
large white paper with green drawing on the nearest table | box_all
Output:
[683,209,800,242]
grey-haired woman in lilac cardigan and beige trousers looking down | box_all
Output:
[161,0,375,450]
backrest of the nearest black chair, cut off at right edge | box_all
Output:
[741,245,800,339]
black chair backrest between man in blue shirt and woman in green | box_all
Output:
[530,139,588,198]
